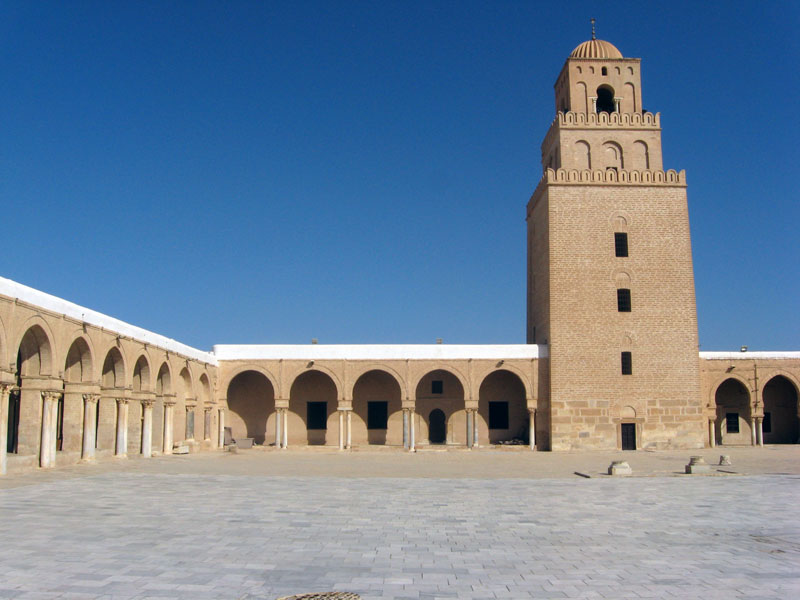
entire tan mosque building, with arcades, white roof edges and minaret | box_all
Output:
[0,34,800,474]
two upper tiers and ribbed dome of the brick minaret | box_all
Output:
[542,36,663,172]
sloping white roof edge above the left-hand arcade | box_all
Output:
[0,277,218,366]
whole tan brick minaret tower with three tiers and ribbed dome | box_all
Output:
[527,29,704,450]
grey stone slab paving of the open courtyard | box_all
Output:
[0,459,800,600]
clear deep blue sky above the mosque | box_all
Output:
[0,1,800,350]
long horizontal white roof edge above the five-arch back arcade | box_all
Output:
[213,344,547,360]
